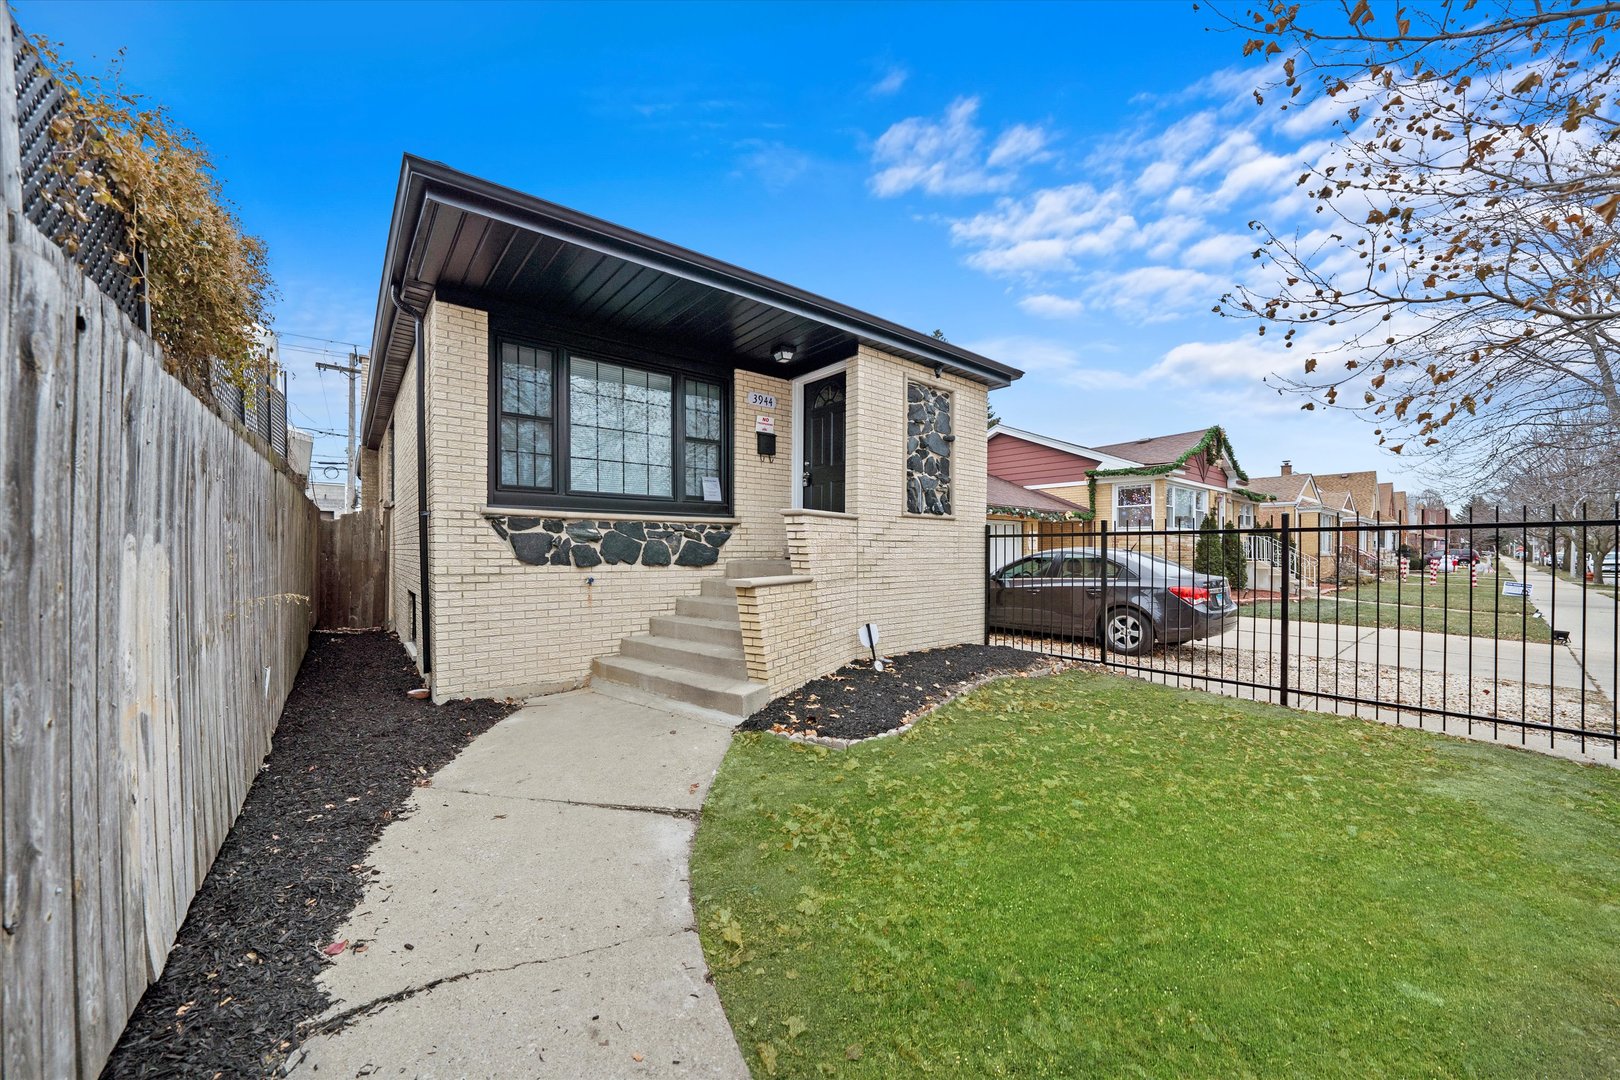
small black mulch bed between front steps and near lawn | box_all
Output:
[740,644,1053,738]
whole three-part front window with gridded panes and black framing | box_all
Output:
[489,325,731,517]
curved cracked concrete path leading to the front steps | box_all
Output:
[288,690,748,1080]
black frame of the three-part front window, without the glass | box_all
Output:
[484,316,735,520]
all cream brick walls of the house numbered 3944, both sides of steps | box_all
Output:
[379,303,987,701]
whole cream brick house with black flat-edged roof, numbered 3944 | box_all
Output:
[361,157,1021,714]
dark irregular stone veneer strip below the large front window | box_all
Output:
[489,515,731,568]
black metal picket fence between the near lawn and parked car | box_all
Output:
[985,507,1620,759]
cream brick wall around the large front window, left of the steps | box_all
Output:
[405,303,792,701]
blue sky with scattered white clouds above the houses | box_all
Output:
[15,0,1422,487]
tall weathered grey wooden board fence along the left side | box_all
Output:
[0,18,316,1077]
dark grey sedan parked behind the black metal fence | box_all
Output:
[988,547,1238,656]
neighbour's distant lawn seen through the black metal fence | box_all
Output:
[1249,570,1552,641]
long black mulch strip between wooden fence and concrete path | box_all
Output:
[102,631,512,1078]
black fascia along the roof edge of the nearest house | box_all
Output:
[363,154,1024,442]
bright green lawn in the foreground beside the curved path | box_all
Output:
[692,672,1620,1077]
